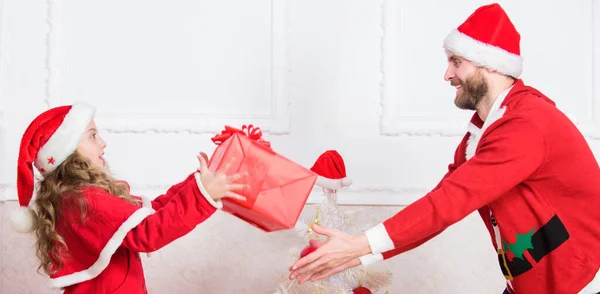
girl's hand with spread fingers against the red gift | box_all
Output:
[198,152,248,201]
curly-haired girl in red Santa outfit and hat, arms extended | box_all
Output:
[11,104,244,294]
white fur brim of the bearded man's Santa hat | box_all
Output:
[444,29,523,78]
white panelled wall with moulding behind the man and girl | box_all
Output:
[0,0,600,293]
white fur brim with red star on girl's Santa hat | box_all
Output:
[35,103,96,174]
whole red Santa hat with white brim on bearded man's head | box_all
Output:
[444,3,523,78]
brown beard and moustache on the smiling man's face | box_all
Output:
[450,71,488,110]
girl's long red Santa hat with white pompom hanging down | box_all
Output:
[10,103,96,233]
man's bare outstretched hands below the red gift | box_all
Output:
[290,225,371,284]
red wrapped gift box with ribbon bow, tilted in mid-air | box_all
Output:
[208,125,317,232]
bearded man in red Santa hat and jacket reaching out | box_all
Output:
[290,4,600,293]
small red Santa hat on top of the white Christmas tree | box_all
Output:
[310,150,352,190]
